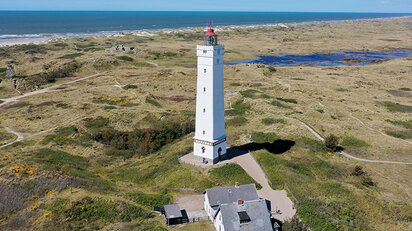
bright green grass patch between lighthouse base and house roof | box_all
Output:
[209,164,261,188]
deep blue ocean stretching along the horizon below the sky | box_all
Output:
[0,11,412,43]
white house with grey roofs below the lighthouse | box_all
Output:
[204,183,273,231]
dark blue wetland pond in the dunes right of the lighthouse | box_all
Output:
[225,49,412,66]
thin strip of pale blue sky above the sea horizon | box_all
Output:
[0,0,412,13]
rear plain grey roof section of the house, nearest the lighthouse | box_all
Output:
[206,184,259,207]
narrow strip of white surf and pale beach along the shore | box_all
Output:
[0,11,412,47]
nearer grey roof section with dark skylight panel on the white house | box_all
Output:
[220,199,273,231]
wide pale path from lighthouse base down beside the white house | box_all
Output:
[231,153,296,221]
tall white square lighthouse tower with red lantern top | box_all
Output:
[194,22,226,164]
